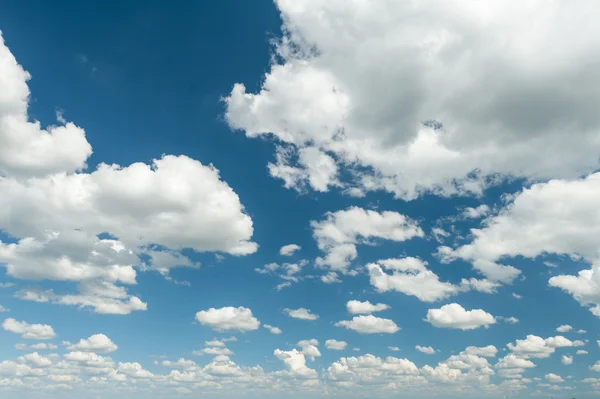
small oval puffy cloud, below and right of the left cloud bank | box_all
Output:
[196,306,260,332]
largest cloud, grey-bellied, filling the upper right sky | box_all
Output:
[226,0,600,199]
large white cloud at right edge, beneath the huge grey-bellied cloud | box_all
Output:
[439,173,600,302]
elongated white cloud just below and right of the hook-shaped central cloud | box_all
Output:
[367,257,460,302]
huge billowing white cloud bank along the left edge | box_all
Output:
[0,31,258,314]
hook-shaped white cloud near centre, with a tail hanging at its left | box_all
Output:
[311,207,424,272]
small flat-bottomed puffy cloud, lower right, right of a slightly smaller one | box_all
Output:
[426,303,496,330]
